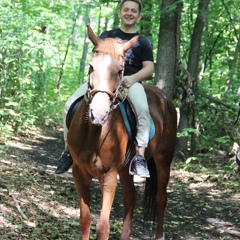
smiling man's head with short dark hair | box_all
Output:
[118,1,142,26]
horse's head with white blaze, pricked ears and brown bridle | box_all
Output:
[87,26,139,126]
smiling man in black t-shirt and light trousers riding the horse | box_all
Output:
[55,0,154,177]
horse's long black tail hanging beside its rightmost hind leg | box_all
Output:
[143,158,157,230]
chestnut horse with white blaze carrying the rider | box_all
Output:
[67,26,177,240]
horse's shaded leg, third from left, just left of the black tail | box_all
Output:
[119,171,137,240]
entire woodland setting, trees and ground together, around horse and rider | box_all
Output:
[0,0,240,240]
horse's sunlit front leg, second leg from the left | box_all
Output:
[96,171,117,240]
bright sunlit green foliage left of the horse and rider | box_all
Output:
[0,1,88,137]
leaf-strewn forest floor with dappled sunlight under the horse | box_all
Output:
[0,126,240,240]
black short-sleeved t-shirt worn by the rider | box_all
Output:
[100,29,153,76]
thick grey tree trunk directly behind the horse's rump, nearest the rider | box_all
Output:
[155,0,179,98]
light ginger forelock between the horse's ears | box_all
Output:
[94,38,124,58]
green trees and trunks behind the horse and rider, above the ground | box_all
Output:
[0,0,240,163]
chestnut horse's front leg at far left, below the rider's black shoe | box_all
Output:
[72,164,92,240]
